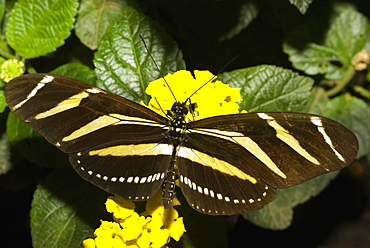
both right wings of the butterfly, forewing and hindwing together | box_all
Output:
[177,113,358,214]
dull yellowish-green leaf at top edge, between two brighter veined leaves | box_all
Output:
[75,0,122,50]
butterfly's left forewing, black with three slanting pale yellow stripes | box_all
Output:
[5,74,167,153]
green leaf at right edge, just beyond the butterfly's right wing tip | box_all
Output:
[324,94,370,158]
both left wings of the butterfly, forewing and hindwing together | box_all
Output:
[5,74,172,200]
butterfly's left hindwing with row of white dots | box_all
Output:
[69,144,171,201]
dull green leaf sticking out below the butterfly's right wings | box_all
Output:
[243,172,338,230]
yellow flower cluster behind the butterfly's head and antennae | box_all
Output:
[145,70,242,121]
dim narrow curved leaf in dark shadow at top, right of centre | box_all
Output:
[220,1,259,40]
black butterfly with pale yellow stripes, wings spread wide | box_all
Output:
[5,74,358,215]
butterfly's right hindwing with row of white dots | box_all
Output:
[178,155,276,215]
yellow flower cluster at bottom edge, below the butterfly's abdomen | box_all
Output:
[83,191,186,248]
